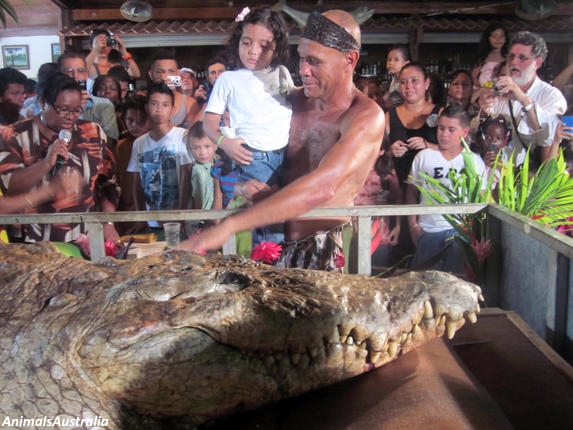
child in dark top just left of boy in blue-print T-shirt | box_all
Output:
[115,95,151,236]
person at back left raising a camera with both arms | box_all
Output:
[86,28,141,79]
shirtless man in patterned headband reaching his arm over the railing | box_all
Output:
[181,10,384,270]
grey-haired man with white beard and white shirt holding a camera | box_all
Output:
[472,31,567,165]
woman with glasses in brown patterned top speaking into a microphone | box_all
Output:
[0,73,119,242]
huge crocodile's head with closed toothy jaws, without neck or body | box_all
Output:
[0,242,480,424]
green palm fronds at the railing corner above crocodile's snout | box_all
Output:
[416,141,573,282]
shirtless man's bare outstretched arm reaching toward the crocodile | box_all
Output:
[181,96,384,251]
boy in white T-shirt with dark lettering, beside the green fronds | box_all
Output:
[406,104,485,273]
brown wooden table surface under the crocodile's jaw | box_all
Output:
[203,309,573,430]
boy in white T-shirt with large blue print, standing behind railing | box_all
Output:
[127,82,193,232]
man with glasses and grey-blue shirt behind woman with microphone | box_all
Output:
[58,51,119,142]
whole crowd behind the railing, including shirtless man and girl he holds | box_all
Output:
[0,12,573,272]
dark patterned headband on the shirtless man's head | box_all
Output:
[301,12,360,52]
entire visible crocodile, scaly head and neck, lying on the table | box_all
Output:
[0,243,480,429]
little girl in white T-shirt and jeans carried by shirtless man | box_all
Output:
[203,8,294,244]
